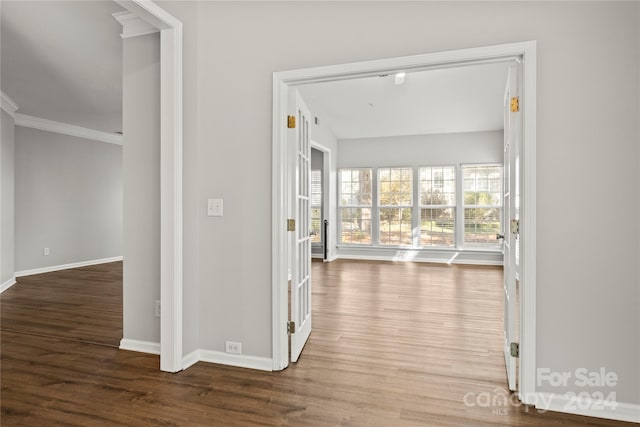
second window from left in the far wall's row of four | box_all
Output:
[378,168,413,245]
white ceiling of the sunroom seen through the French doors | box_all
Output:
[298,63,508,139]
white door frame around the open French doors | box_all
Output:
[271,41,536,404]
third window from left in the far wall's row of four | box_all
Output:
[419,166,456,247]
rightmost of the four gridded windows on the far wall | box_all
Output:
[462,164,503,248]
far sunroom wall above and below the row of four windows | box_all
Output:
[336,131,504,265]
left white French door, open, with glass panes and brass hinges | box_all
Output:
[291,90,311,362]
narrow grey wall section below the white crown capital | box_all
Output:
[122,33,160,343]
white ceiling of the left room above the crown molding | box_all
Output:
[0,0,123,132]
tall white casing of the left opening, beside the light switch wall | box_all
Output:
[115,0,182,372]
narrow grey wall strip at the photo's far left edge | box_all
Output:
[0,110,15,285]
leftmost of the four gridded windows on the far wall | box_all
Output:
[338,168,372,244]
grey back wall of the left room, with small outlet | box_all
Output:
[15,126,122,272]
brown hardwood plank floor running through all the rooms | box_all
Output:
[0,260,629,426]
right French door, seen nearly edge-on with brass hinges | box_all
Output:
[502,63,522,390]
